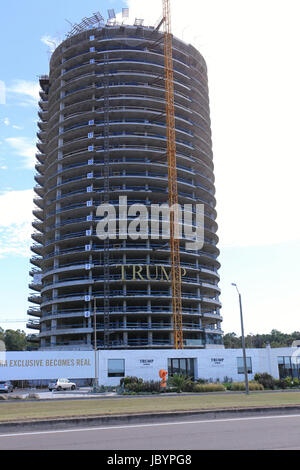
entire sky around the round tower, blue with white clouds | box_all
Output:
[0,0,300,334]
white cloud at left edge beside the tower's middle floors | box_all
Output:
[0,190,34,258]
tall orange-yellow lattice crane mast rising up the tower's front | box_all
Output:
[162,0,183,349]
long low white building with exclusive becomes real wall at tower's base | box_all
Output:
[0,346,300,386]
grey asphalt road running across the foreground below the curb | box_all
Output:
[0,415,300,450]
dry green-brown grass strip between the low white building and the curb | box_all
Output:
[0,392,300,422]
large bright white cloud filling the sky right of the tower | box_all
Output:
[127,0,300,246]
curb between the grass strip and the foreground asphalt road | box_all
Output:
[0,405,300,432]
